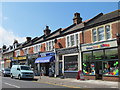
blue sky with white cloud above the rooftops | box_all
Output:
[0,2,118,47]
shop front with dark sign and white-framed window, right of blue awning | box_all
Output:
[56,47,79,78]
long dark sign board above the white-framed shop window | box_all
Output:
[56,47,79,55]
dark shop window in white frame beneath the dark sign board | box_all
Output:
[64,55,78,71]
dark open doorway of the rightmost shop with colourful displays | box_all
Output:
[95,61,102,80]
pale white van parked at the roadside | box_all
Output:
[10,65,34,80]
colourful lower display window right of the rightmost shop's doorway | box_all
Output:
[103,61,118,76]
